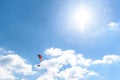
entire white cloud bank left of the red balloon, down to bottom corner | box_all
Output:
[0,49,35,80]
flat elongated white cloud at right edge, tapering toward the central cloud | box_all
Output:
[93,55,120,64]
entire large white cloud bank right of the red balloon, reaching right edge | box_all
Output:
[36,48,120,80]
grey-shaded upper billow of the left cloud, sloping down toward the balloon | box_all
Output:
[0,54,34,75]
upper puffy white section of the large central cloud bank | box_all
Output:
[45,48,91,67]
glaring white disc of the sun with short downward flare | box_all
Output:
[72,6,92,32]
